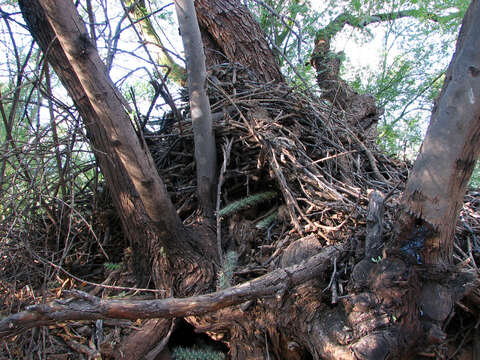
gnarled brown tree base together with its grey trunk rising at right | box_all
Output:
[191,0,480,360]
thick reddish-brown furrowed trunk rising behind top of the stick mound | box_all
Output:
[195,0,284,82]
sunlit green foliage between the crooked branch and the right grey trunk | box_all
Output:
[334,0,469,159]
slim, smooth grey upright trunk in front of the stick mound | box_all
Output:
[175,0,217,220]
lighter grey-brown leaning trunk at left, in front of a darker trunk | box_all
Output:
[37,0,182,232]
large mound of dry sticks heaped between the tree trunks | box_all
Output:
[146,64,408,263]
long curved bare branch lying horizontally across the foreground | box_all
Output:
[0,245,346,339]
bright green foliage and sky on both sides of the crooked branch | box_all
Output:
[250,0,470,166]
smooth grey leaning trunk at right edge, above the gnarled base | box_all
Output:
[399,0,480,265]
